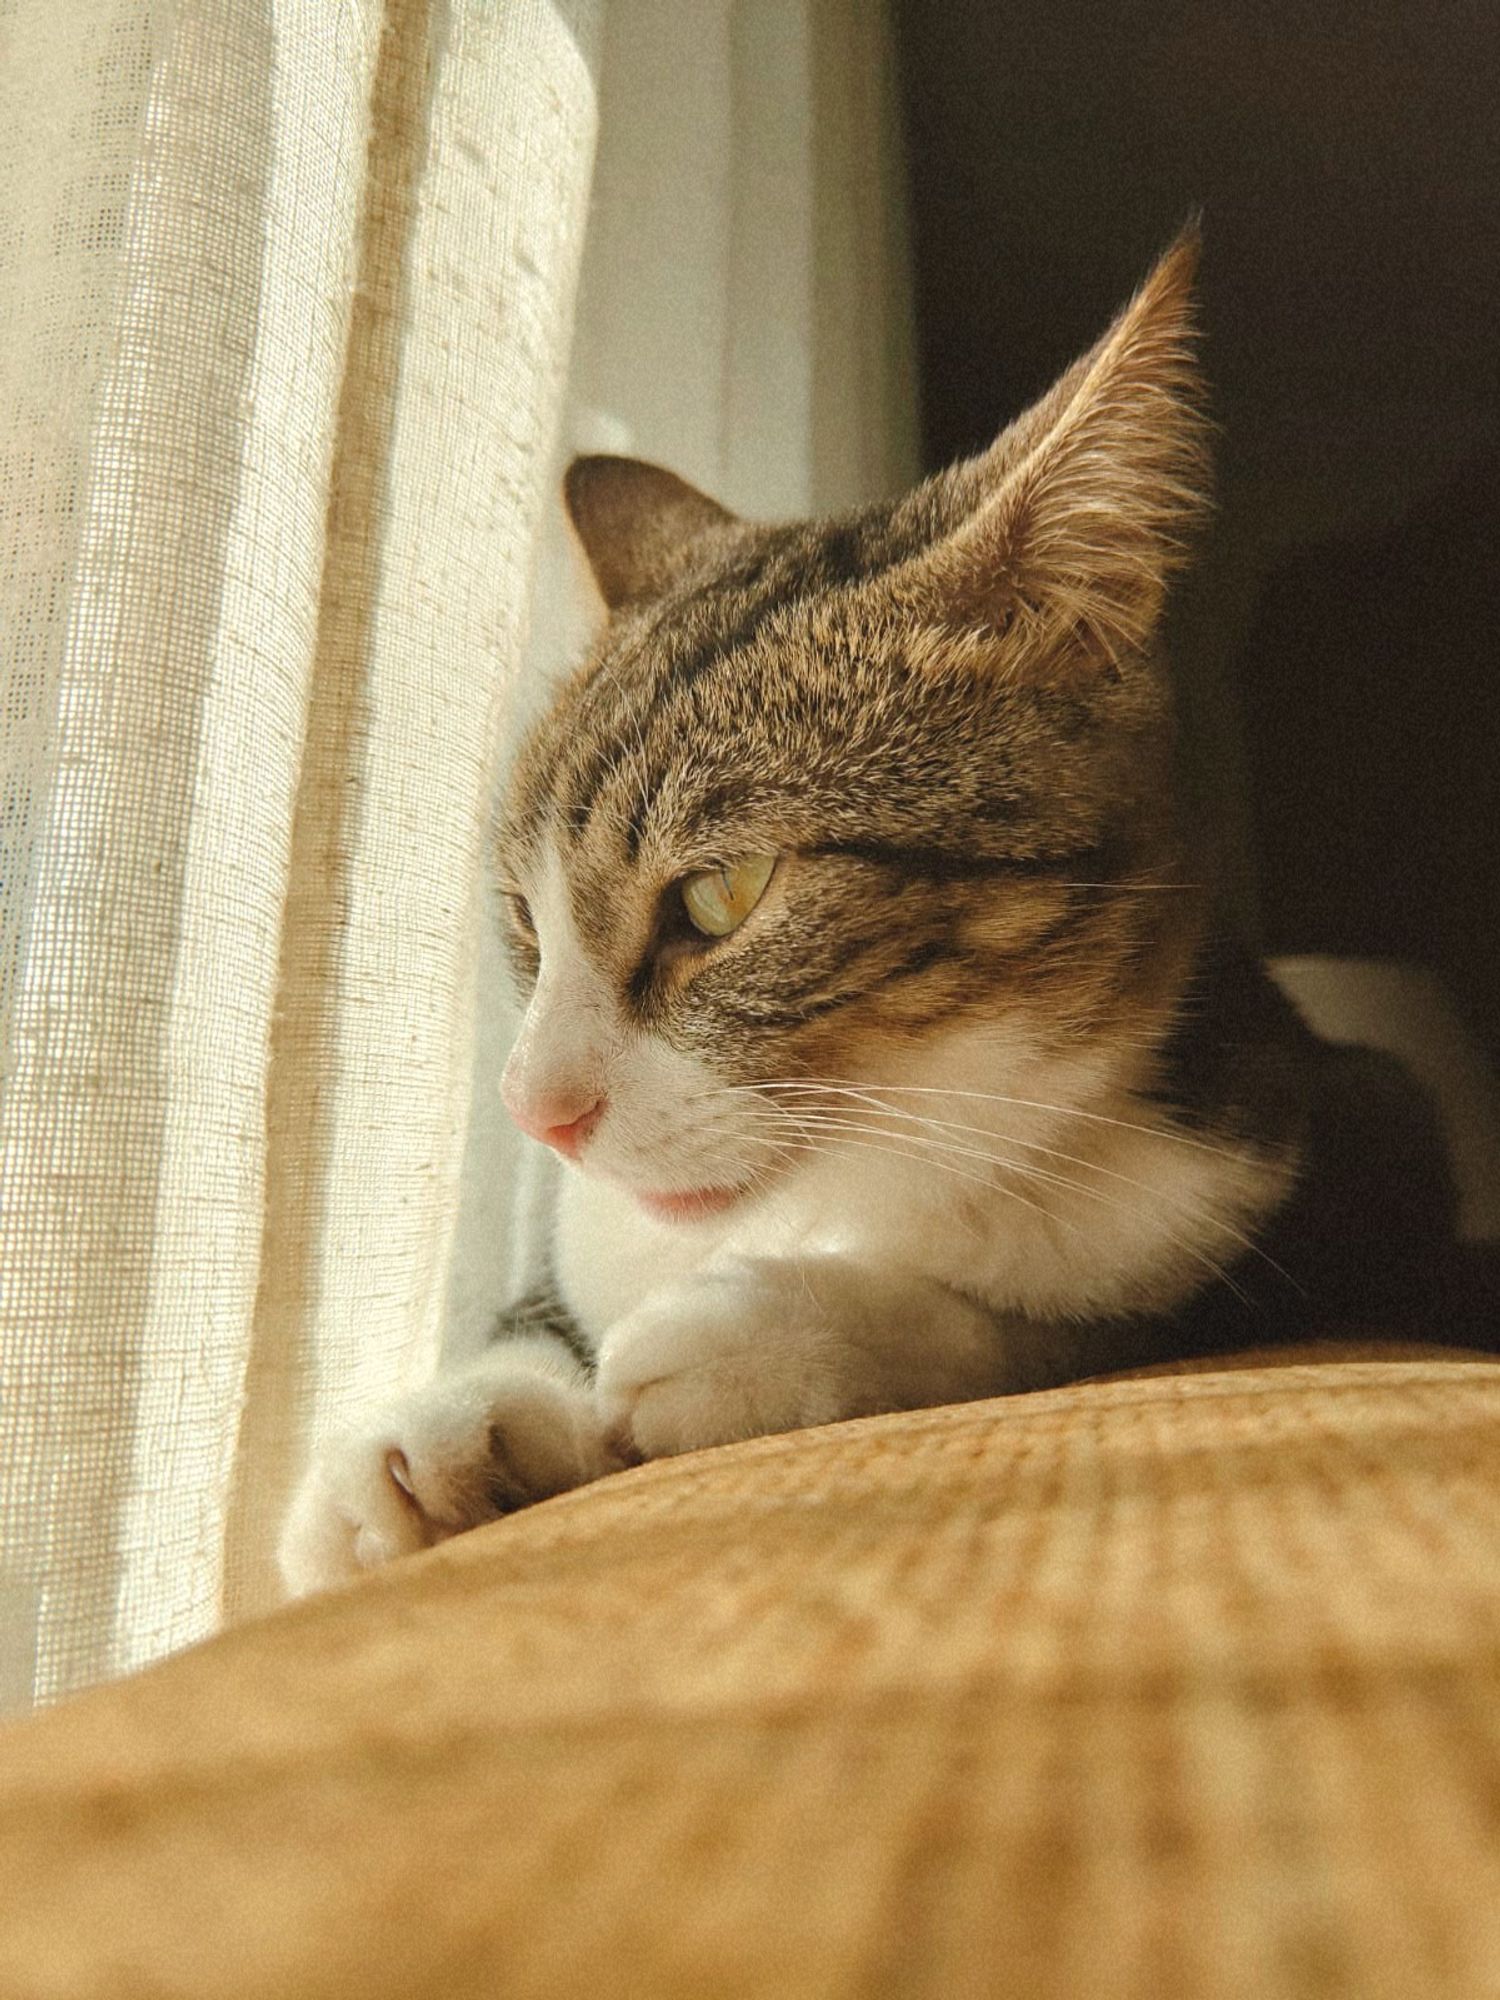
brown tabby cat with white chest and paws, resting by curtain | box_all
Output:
[282,232,1450,1590]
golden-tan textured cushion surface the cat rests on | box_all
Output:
[0,1350,1500,2000]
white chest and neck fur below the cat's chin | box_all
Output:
[556,1044,1292,1342]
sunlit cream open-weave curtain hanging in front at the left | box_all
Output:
[0,0,596,1702]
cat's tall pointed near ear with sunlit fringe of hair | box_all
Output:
[892,228,1208,680]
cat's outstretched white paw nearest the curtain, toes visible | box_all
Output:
[280,1338,622,1596]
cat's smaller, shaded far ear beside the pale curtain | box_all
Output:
[562,456,736,610]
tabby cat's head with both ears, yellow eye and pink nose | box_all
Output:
[498,238,1204,1216]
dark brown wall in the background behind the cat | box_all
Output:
[896,0,1500,1054]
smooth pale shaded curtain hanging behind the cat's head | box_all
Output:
[448,0,918,1354]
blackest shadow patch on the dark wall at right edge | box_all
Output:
[1238,460,1500,1058]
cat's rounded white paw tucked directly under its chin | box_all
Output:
[598,1260,854,1458]
